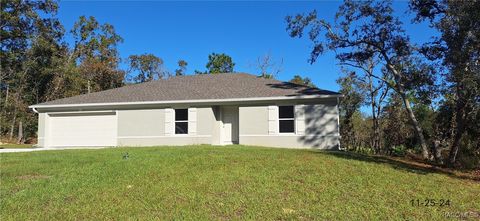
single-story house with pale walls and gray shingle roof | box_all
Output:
[30,73,341,149]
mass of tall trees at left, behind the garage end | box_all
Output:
[0,4,128,142]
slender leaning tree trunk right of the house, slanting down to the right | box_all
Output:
[387,63,429,160]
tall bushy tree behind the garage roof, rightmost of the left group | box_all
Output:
[70,16,125,93]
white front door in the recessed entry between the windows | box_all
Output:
[222,107,238,144]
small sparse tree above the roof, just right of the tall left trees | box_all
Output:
[128,54,169,83]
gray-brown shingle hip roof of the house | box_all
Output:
[35,73,339,106]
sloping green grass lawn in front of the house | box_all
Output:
[0,146,480,220]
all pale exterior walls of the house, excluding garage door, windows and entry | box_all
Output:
[38,98,340,149]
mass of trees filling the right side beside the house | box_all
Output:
[286,0,480,166]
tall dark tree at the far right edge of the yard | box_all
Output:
[410,0,480,165]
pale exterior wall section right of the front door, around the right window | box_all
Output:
[239,99,340,149]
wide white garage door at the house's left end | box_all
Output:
[48,113,117,147]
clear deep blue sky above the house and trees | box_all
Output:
[54,1,435,91]
